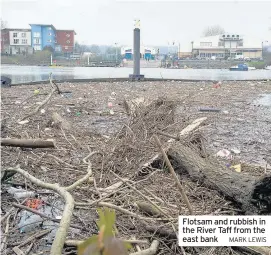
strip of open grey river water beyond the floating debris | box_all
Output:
[1,65,271,84]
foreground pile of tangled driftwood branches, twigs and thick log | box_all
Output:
[1,79,271,255]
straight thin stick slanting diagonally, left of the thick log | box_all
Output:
[154,135,193,215]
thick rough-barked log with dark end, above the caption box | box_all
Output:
[168,143,271,214]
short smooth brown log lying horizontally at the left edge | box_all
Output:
[1,138,55,148]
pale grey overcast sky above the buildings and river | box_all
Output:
[1,0,271,48]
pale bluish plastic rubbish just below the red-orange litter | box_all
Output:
[18,210,43,233]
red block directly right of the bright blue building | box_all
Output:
[55,30,76,53]
